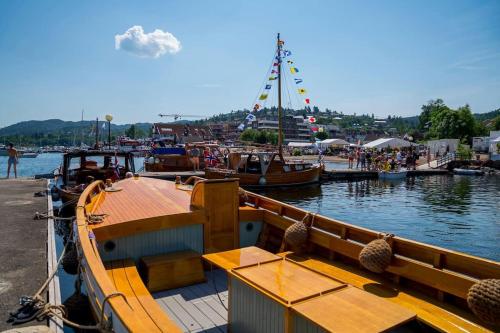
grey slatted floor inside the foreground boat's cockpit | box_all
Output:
[153,270,228,333]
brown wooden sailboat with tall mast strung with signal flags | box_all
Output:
[205,34,323,187]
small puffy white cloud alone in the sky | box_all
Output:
[115,25,181,58]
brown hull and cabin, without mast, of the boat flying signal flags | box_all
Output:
[205,152,322,187]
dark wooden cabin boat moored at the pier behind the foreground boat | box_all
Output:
[56,150,135,207]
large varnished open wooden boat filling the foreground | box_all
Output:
[75,172,500,333]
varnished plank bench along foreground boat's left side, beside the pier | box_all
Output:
[104,259,182,333]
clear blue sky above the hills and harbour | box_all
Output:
[0,0,500,127]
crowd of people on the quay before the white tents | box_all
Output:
[347,148,419,171]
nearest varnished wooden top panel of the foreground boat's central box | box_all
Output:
[292,287,416,333]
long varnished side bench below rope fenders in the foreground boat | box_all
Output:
[278,252,493,332]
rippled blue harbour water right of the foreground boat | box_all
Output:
[260,175,500,261]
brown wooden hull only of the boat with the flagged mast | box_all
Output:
[205,167,321,187]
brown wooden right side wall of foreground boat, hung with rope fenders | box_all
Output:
[247,188,500,299]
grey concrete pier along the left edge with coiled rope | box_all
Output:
[0,179,47,331]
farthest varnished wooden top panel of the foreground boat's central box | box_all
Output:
[202,246,281,270]
